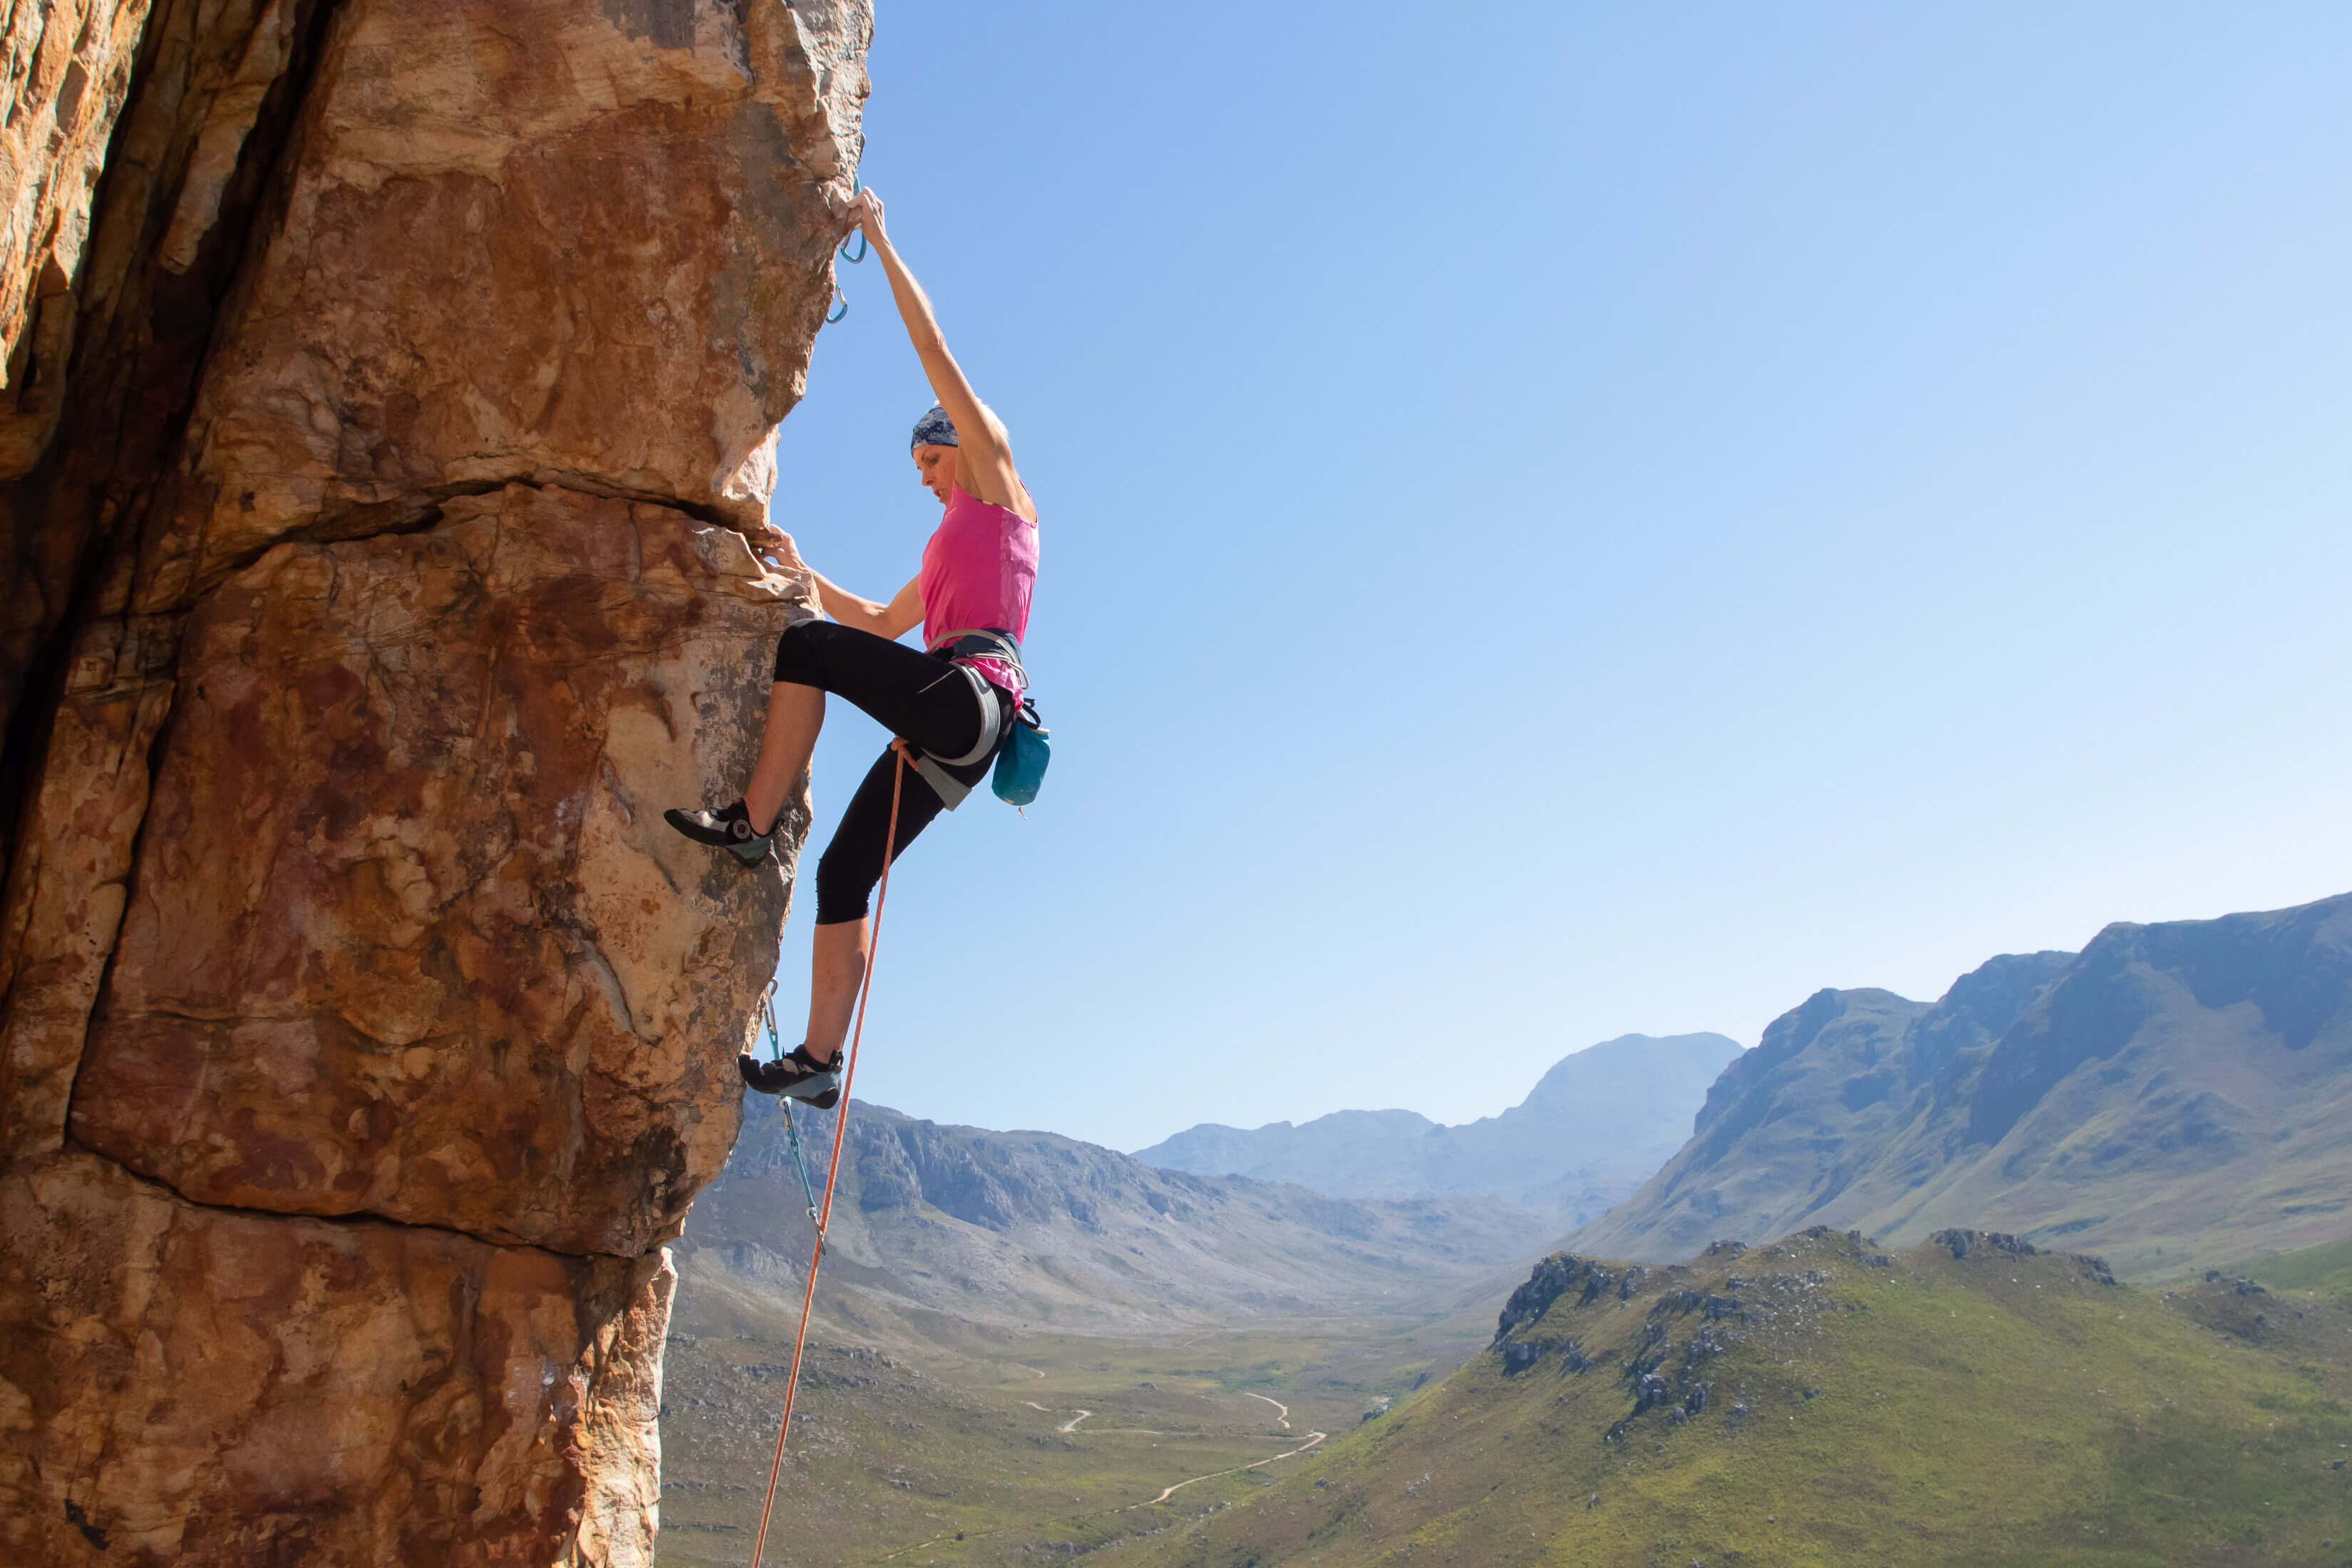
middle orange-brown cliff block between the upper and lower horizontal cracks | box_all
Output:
[73,484,798,1255]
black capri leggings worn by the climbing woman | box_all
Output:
[776,621,1011,927]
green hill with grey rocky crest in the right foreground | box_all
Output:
[1100,1229,2352,1568]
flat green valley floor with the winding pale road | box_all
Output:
[659,1314,1491,1568]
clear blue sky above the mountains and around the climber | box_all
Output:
[776,0,2352,1147]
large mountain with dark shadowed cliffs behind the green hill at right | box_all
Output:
[1571,896,2352,1274]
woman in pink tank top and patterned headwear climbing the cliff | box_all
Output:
[666,190,1037,1110]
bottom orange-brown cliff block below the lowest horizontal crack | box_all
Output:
[0,1154,677,1566]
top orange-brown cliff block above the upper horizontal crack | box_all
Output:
[146,0,870,599]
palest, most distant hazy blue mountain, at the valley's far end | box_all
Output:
[1136,1034,1740,1224]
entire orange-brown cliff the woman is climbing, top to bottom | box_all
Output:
[0,0,870,1563]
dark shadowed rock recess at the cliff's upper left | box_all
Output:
[0,0,329,785]
